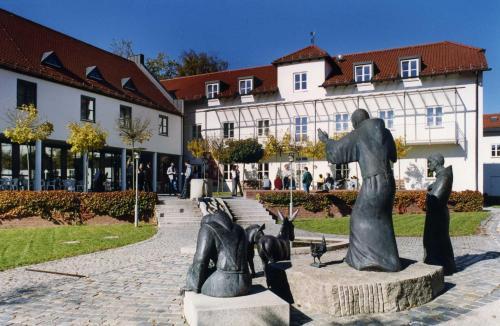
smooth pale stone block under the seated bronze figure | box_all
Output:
[184,286,290,326]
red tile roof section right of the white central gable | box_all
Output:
[323,41,488,87]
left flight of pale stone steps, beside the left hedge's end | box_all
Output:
[156,196,202,225]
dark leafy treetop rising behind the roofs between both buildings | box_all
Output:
[177,50,229,76]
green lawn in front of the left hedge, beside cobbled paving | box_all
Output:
[0,224,156,271]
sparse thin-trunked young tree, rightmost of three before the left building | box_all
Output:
[116,117,153,189]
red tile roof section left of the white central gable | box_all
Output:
[161,66,278,101]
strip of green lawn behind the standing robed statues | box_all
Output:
[294,212,489,237]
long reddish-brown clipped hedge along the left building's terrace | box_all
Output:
[0,191,158,224]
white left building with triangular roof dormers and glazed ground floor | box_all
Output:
[0,10,182,189]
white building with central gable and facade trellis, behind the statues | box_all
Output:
[162,42,488,190]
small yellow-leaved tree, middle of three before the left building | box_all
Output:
[66,122,108,192]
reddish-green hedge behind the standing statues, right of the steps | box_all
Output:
[256,190,483,216]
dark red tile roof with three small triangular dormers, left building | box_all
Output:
[0,9,180,114]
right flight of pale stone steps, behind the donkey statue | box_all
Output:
[224,197,280,234]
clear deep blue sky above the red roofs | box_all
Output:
[0,0,500,113]
